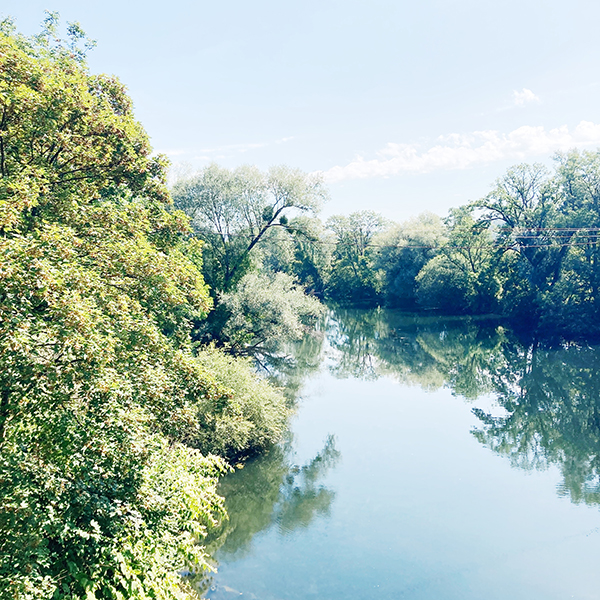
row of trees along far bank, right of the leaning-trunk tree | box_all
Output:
[172,150,600,339]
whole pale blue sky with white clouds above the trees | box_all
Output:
[0,0,600,220]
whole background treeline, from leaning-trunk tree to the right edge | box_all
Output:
[173,150,600,338]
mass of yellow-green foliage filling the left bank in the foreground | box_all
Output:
[0,15,287,600]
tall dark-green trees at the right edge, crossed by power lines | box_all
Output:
[474,151,600,337]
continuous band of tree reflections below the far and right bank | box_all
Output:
[328,310,600,504]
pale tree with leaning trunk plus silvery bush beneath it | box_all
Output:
[173,164,327,359]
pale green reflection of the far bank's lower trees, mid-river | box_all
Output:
[328,310,503,398]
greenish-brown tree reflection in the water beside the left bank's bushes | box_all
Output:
[193,436,340,594]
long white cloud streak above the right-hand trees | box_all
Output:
[323,121,600,183]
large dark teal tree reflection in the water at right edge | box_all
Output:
[474,343,600,504]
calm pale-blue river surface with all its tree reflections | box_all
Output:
[198,311,600,600]
